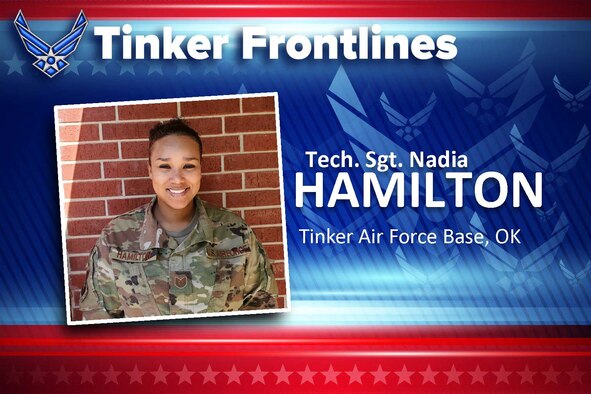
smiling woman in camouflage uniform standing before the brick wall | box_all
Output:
[80,118,277,320]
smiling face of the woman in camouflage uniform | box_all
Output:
[149,135,201,210]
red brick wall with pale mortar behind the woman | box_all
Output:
[56,96,286,320]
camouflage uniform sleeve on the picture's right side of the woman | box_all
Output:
[240,230,278,310]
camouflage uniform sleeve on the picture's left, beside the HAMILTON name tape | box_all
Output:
[80,239,123,320]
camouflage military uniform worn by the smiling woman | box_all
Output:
[80,198,277,320]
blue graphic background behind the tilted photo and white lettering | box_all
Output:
[0,15,591,325]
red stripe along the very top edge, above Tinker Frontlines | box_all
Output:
[0,0,591,20]
